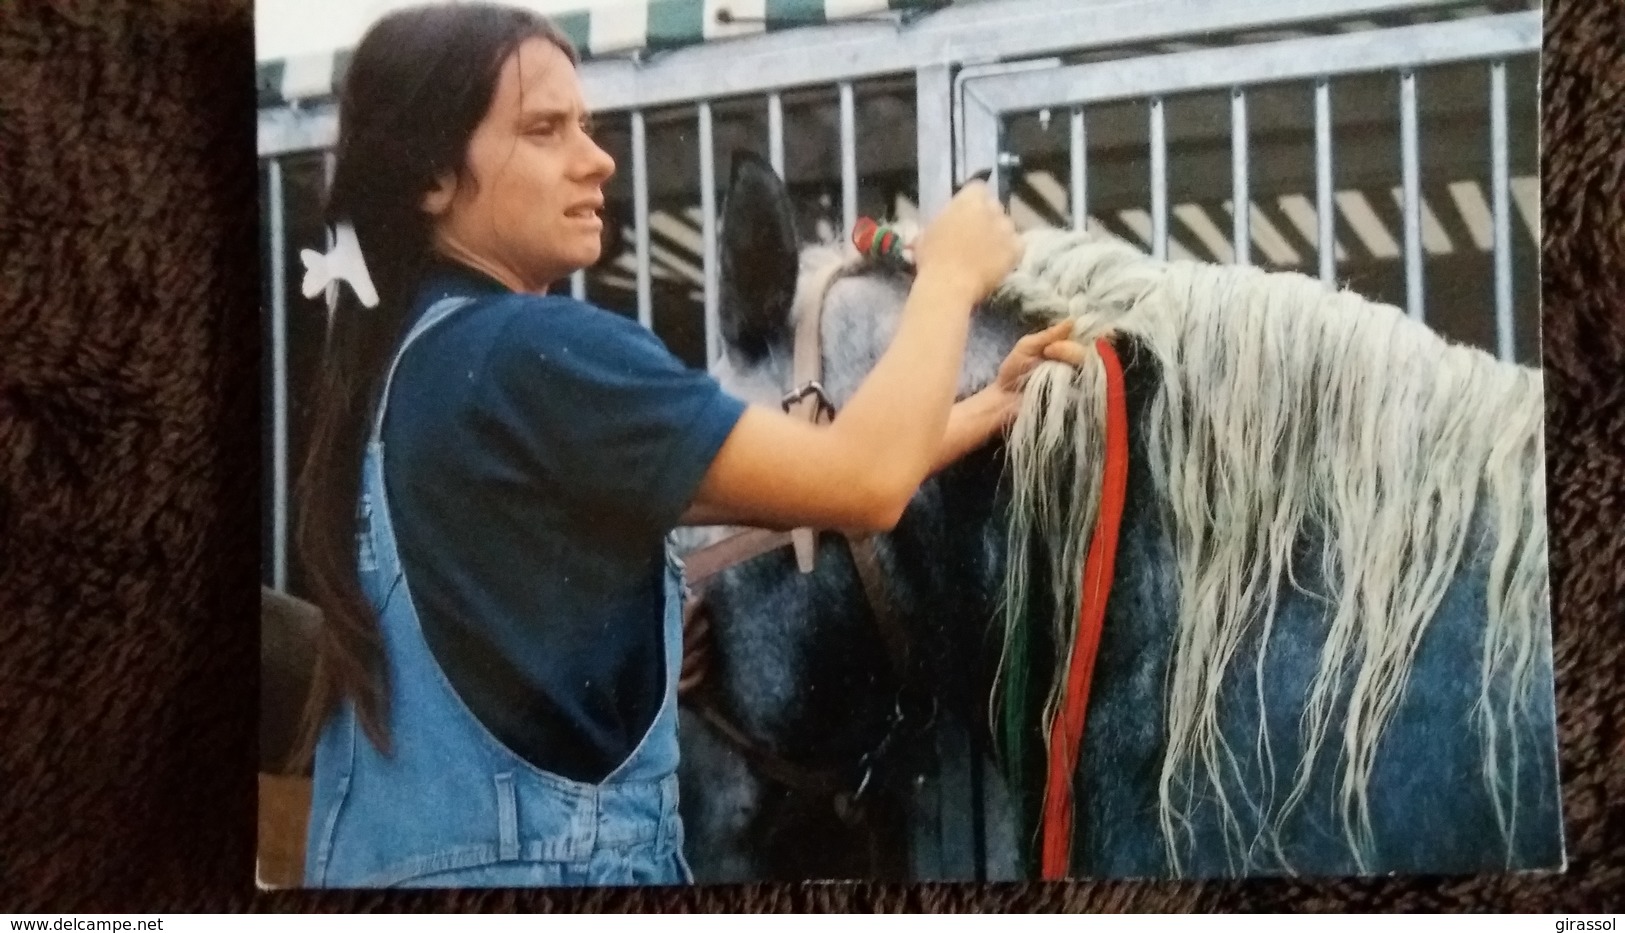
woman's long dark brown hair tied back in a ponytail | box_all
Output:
[291,3,577,769]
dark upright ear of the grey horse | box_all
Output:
[717,150,800,362]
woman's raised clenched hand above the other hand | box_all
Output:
[913,180,1022,304]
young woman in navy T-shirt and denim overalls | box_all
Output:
[290,3,1081,887]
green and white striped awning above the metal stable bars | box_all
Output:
[255,0,954,107]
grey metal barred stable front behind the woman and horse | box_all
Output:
[258,0,1541,879]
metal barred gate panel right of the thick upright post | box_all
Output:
[956,11,1541,359]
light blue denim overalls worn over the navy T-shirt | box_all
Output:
[306,297,694,887]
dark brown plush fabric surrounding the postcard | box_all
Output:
[0,0,1625,912]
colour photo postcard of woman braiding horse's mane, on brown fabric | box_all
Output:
[255,0,1567,887]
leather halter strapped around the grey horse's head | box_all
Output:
[678,227,936,822]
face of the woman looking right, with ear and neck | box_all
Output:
[423,39,614,293]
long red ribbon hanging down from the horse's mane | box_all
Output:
[1040,340,1128,881]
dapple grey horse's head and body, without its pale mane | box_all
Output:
[669,153,1565,881]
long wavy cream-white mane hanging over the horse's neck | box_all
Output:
[995,231,1549,871]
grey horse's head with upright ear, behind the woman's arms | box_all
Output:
[679,153,1022,878]
